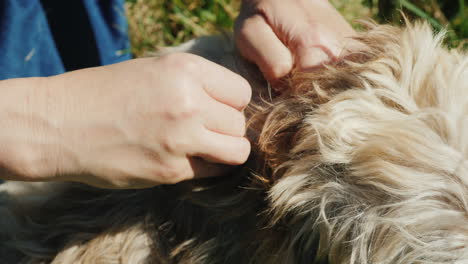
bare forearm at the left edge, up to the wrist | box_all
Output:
[0,78,76,181]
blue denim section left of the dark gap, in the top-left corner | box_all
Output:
[0,0,64,80]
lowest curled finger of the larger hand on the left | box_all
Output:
[189,129,250,165]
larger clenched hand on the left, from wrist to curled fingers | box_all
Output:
[0,54,251,188]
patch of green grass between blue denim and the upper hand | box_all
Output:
[127,0,240,56]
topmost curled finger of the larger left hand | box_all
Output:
[200,57,252,110]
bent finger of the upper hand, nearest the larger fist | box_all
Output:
[236,15,293,80]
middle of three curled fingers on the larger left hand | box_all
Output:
[203,100,245,137]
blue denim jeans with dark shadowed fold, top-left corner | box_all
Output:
[0,0,131,80]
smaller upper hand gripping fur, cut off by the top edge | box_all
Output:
[235,0,355,81]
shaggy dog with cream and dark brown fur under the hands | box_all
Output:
[0,21,468,264]
